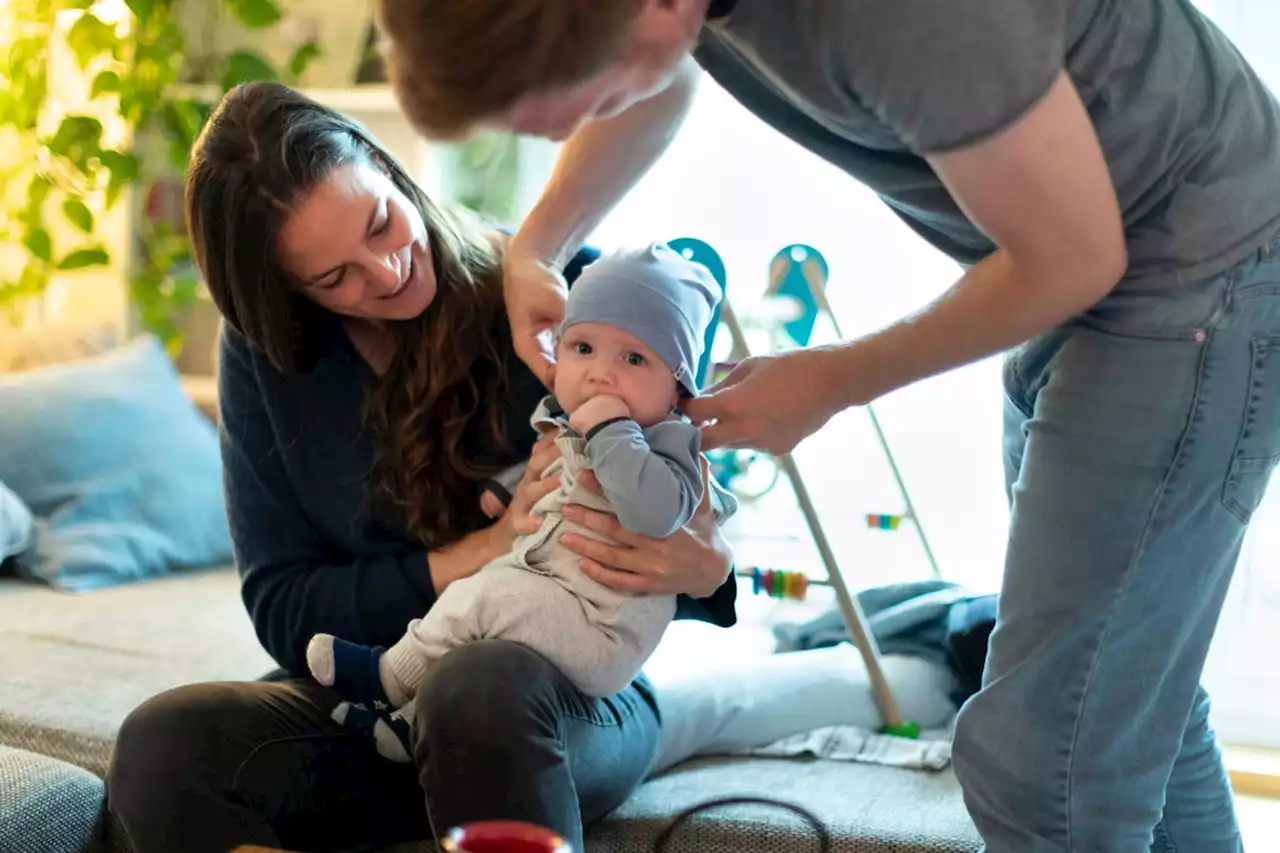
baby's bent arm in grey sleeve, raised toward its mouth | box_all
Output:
[586,418,703,537]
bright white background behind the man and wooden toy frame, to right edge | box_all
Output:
[595,0,1280,745]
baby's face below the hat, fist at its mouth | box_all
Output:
[554,323,680,427]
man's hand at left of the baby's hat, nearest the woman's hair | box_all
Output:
[502,246,568,388]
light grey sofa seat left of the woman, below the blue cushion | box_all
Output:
[0,569,274,775]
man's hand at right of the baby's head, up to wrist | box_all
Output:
[685,348,847,455]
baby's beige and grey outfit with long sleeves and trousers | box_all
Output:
[384,397,737,697]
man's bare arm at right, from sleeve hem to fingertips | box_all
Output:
[686,73,1128,452]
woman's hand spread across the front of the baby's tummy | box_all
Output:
[561,459,733,598]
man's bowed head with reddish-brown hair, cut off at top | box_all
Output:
[378,0,708,140]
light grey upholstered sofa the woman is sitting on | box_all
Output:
[0,569,978,853]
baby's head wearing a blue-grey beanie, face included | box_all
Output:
[556,243,723,427]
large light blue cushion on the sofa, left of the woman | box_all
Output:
[0,336,232,590]
